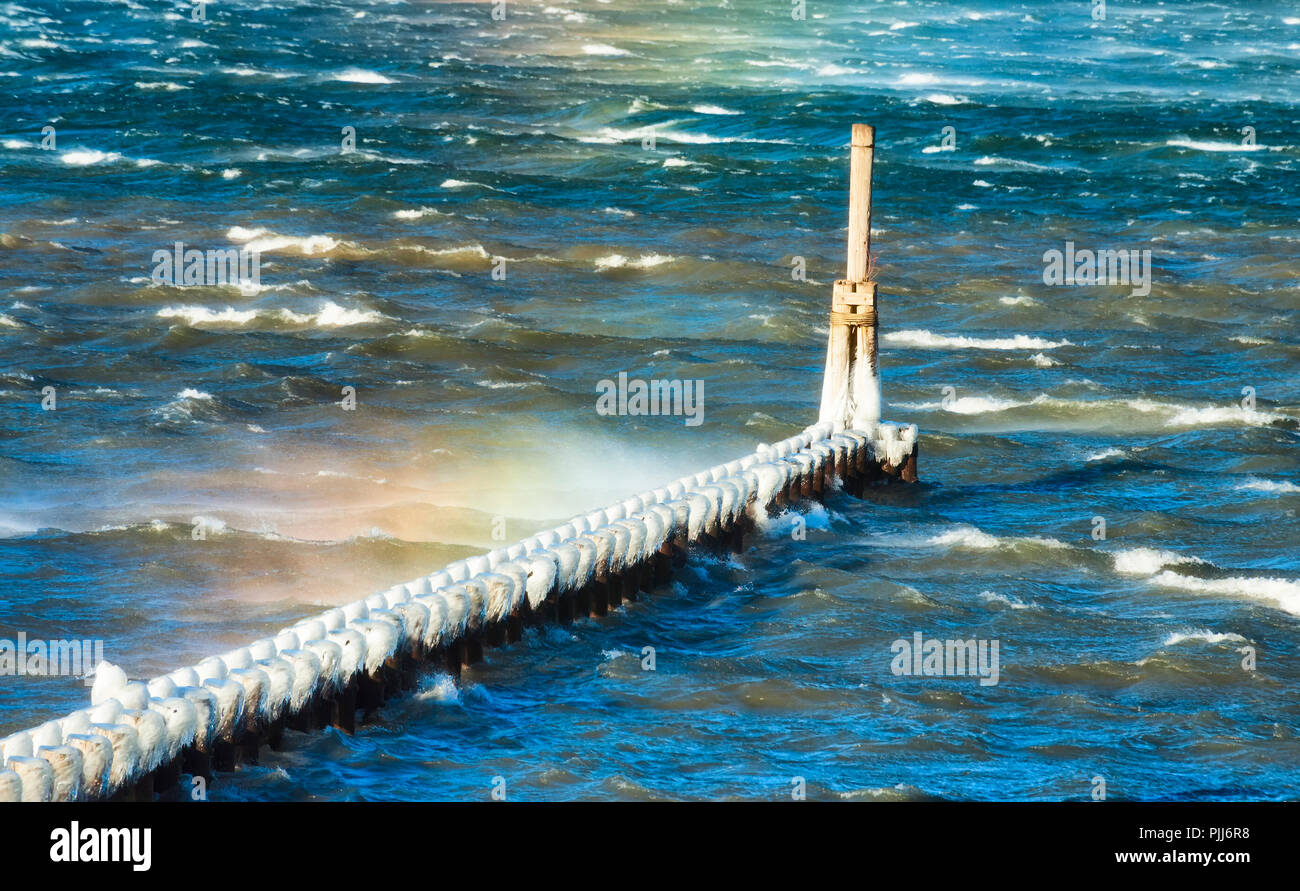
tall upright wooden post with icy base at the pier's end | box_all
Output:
[818,124,880,431]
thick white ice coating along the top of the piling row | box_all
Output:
[0,424,917,801]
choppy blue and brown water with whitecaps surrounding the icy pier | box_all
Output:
[0,0,1300,799]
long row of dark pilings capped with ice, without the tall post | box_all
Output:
[0,424,917,801]
